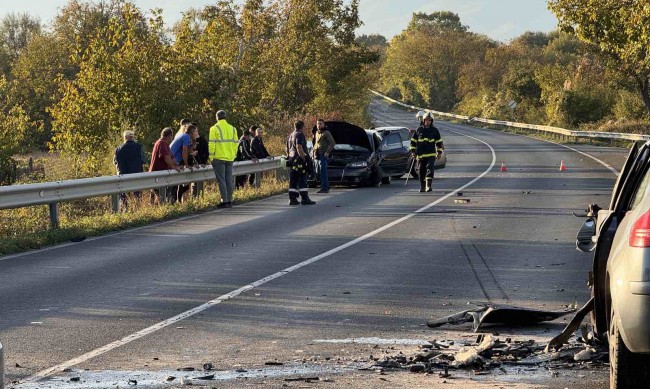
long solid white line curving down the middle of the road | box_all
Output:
[25,131,496,382]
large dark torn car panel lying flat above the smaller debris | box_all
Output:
[427,302,576,331]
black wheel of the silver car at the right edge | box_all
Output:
[609,312,650,389]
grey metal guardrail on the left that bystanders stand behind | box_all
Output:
[0,158,282,226]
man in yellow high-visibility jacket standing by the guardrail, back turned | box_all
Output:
[208,111,239,208]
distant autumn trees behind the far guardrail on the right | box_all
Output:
[372,7,650,132]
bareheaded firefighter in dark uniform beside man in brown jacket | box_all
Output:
[286,120,316,205]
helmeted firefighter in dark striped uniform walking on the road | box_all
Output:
[411,112,445,192]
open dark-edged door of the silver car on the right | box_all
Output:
[589,142,650,336]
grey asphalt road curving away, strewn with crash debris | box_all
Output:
[0,98,626,388]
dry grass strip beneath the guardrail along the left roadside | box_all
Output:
[0,173,287,255]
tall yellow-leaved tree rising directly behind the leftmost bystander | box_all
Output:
[50,2,177,174]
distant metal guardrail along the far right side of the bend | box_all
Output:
[370,90,650,140]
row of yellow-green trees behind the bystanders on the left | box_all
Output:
[0,0,378,175]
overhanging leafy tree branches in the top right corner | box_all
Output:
[548,0,650,112]
